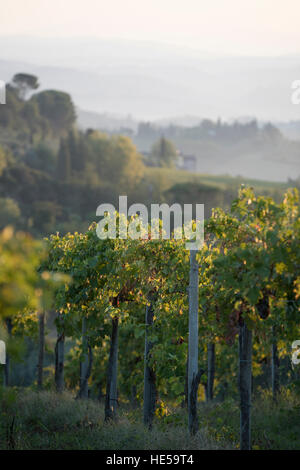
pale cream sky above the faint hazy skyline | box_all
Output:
[0,0,300,55]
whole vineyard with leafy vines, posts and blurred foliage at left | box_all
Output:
[0,187,300,449]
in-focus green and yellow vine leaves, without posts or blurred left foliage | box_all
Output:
[39,188,299,403]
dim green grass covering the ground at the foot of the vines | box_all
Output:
[0,389,300,450]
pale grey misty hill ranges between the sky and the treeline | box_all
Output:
[0,37,300,121]
